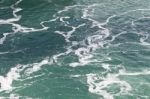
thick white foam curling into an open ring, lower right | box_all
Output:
[87,74,132,99]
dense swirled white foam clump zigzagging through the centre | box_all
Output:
[70,30,109,67]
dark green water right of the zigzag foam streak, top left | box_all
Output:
[18,0,72,28]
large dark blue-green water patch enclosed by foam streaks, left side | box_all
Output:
[0,31,66,74]
